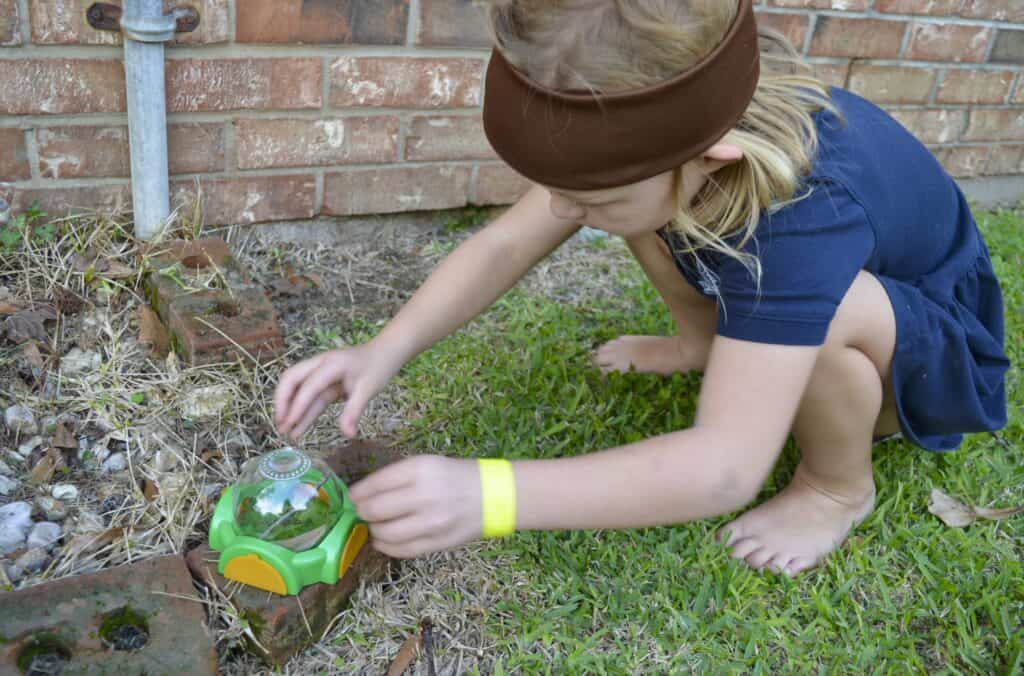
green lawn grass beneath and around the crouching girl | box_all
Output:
[399,212,1024,674]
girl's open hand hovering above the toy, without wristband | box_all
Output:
[273,342,401,438]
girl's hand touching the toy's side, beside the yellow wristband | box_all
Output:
[348,456,482,558]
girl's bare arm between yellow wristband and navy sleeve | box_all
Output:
[514,337,820,530]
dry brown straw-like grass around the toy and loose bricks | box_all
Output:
[0,204,628,674]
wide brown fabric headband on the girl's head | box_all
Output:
[483,0,760,191]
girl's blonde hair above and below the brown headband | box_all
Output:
[489,0,838,280]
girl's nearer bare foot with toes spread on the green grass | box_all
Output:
[718,465,874,576]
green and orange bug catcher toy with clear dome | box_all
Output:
[210,448,368,595]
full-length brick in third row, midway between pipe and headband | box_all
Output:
[234,116,398,169]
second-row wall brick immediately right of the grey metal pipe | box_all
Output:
[167,57,324,113]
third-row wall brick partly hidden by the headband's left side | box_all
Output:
[406,115,498,162]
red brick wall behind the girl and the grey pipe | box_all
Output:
[0,0,1024,223]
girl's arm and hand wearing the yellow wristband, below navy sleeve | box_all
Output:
[349,337,820,557]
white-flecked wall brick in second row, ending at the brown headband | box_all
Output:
[331,56,484,108]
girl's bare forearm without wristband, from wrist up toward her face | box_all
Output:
[374,185,580,364]
